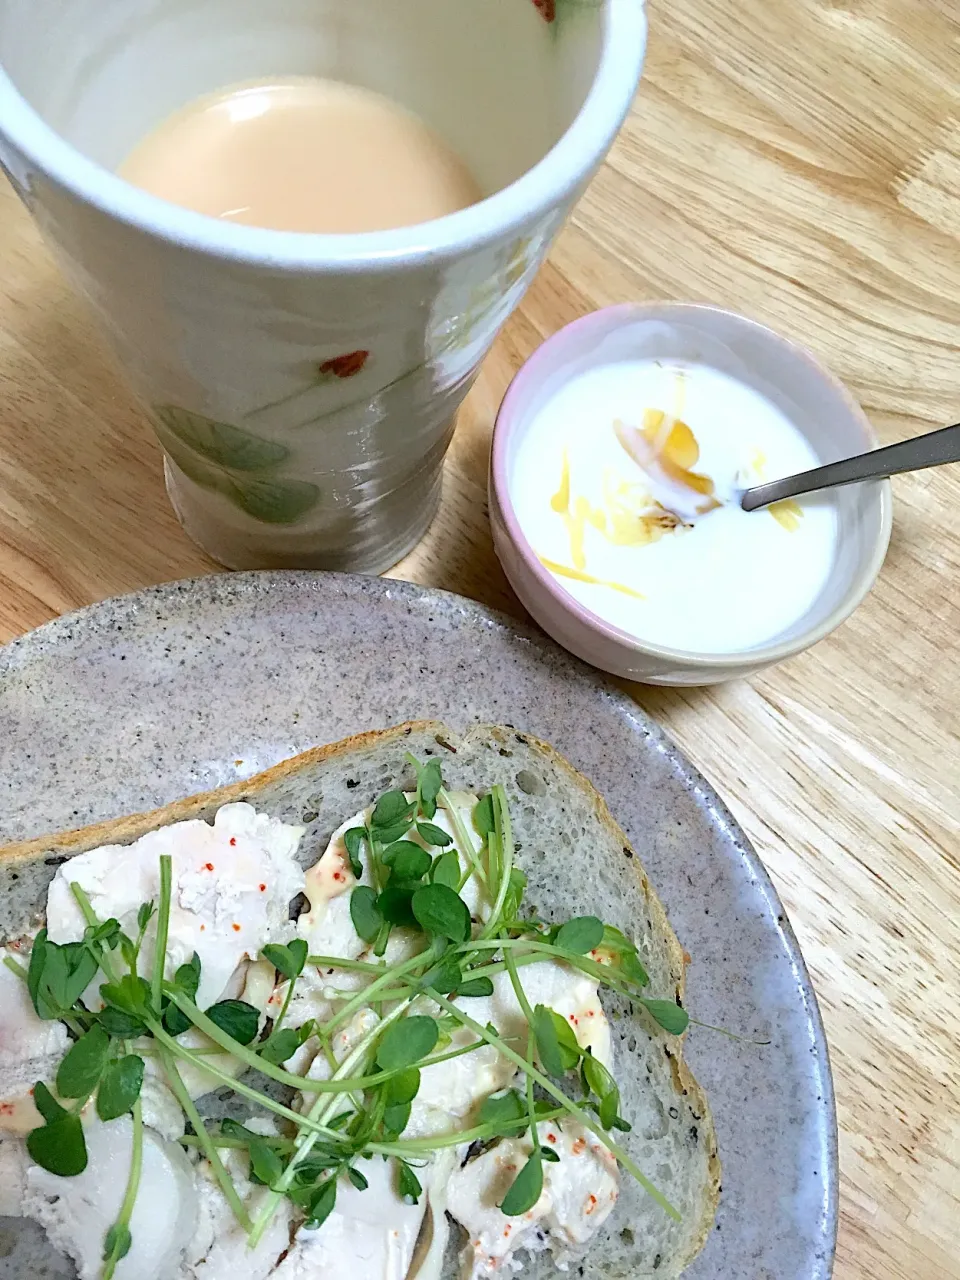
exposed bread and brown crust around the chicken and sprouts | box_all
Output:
[0,722,719,1280]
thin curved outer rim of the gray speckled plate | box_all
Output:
[0,570,840,1280]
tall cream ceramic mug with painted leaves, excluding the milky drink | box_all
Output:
[0,0,646,572]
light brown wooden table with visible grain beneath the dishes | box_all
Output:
[0,0,960,1280]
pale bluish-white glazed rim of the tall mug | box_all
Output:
[0,0,646,273]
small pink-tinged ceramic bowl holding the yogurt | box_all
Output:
[490,303,892,685]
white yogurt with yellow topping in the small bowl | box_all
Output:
[511,361,837,654]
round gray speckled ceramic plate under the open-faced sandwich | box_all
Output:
[0,573,837,1280]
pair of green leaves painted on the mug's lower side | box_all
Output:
[152,404,320,525]
